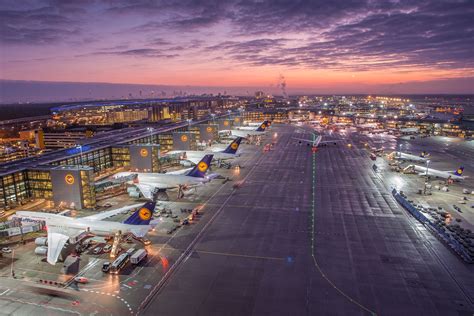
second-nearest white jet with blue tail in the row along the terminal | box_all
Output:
[114,154,215,199]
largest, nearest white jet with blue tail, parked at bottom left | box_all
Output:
[14,202,156,265]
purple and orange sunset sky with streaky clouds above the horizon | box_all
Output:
[0,0,474,93]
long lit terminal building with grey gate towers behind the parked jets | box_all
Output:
[0,114,241,211]
